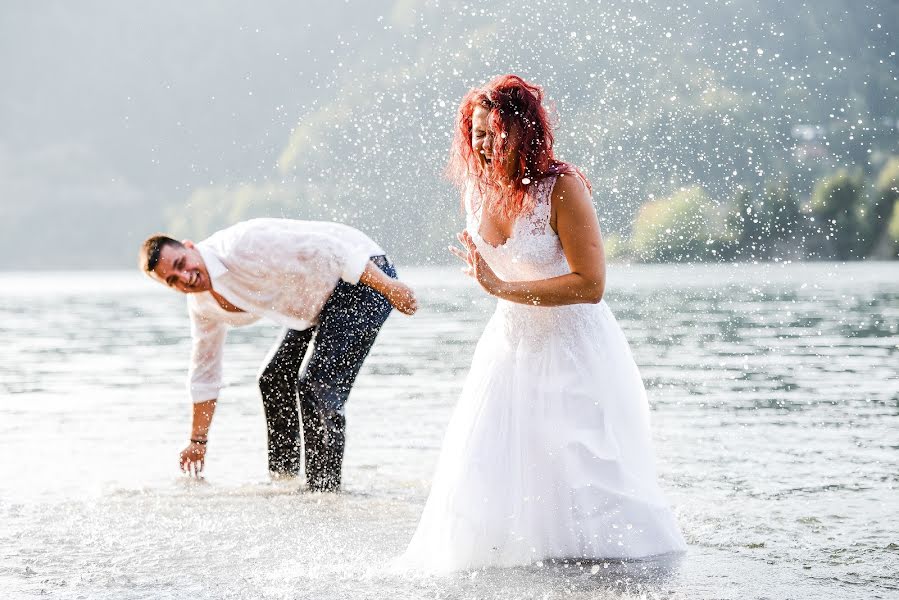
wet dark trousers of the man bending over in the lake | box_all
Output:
[259,256,396,491]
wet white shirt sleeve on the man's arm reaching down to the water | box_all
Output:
[187,310,228,404]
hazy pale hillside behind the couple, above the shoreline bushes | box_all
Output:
[0,0,899,270]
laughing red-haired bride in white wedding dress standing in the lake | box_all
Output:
[400,75,686,572]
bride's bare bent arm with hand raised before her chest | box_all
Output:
[453,176,606,306]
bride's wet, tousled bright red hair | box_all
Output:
[446,75,590,219]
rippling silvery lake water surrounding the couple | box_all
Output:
[0,263,899,600]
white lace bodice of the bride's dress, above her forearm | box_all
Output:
[465,176,570,281]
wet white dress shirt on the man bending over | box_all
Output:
[187,219,384,402]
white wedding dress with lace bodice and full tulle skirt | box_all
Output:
[398,177,686,573]
